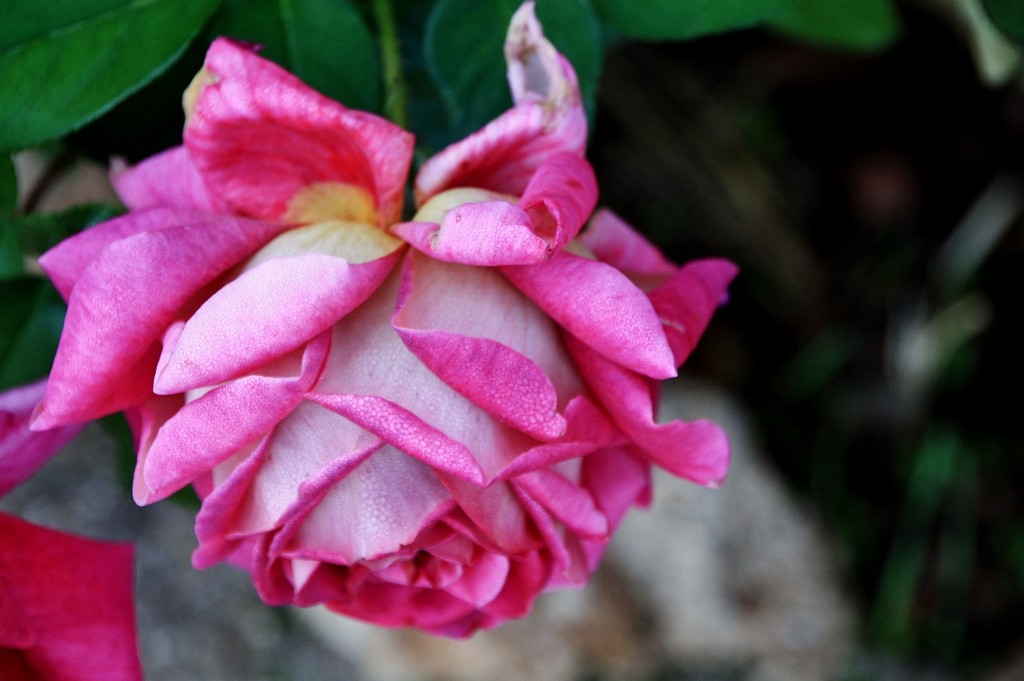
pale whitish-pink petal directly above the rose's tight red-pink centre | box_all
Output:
[271,445,451,565]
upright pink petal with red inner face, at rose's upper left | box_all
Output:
[184,39,413,227]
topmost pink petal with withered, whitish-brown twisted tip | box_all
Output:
[416,2,587,201]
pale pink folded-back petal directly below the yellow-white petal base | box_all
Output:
[154,253,397,394]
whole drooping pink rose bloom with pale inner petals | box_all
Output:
[33,3,735,636]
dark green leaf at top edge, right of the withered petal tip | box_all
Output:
[594,0,778,40]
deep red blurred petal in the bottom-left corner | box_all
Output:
[0,514,142,681]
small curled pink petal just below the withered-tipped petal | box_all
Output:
[519,153,597,253]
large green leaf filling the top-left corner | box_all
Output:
[0,0,219,150]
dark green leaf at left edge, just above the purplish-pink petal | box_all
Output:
[0,278,66,390]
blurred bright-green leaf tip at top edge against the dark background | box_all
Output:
[769,0,901,50]
